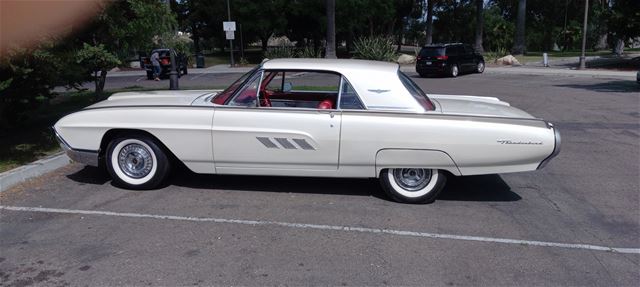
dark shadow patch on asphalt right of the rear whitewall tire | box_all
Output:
[437,174,522,202]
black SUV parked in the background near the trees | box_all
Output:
[416,43,484,77]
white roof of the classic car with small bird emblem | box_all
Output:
[262,58,424,112]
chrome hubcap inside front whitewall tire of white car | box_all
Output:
[118,144,153,178]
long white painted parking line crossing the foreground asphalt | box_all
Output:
[0,205,640,254]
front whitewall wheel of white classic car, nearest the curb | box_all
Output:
[105,136,170,189]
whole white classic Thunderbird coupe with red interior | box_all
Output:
[54,59,560,203]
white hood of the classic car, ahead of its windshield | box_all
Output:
[88,90,212,108]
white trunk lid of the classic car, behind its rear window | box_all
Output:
[429,94,535,119]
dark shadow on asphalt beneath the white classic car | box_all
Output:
[66,166,522,202]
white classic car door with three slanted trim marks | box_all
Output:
[212,72,342,172]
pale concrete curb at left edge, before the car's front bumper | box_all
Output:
[0,152,71,192]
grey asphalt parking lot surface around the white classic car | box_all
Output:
[0,71,640,286]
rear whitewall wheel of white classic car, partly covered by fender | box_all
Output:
[380,168,446,203]
